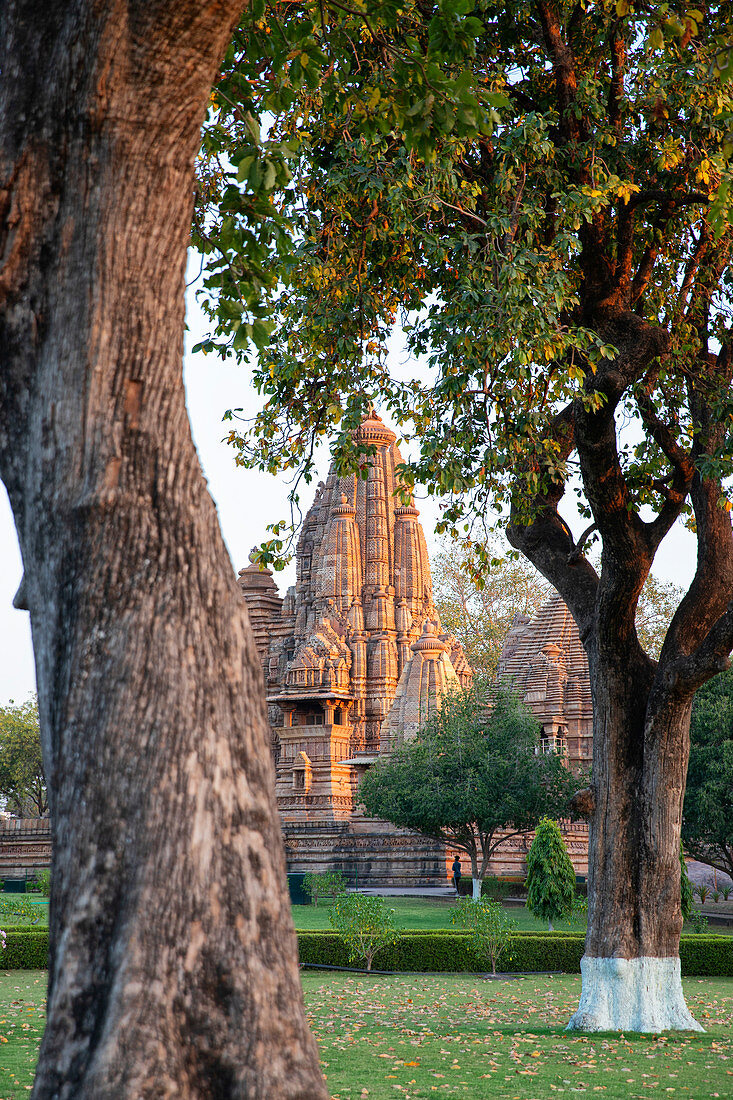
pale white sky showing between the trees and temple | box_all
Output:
[0,260,696,705]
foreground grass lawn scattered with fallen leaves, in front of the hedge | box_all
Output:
[0,970,733,1100]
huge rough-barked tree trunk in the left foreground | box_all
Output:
[0,0,327,1100]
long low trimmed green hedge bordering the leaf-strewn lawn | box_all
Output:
[0,927,733,978]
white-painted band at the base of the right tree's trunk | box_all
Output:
[568,955,704,1032]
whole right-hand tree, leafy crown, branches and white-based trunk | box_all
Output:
[191,0,733,1030]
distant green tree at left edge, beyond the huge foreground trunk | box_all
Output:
[0,696,48,817]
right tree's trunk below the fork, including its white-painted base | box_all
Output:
[568,648,702,1032]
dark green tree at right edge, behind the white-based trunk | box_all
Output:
[682,669,733,876]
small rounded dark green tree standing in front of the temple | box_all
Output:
[359,683,578,900]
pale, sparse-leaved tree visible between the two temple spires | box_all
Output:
[433,540,553,679]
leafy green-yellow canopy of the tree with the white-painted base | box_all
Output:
[195,0,731,594]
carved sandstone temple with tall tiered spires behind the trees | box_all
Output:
[239,411,592,886]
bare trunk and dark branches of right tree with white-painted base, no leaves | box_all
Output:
[499,0,733,1032]
